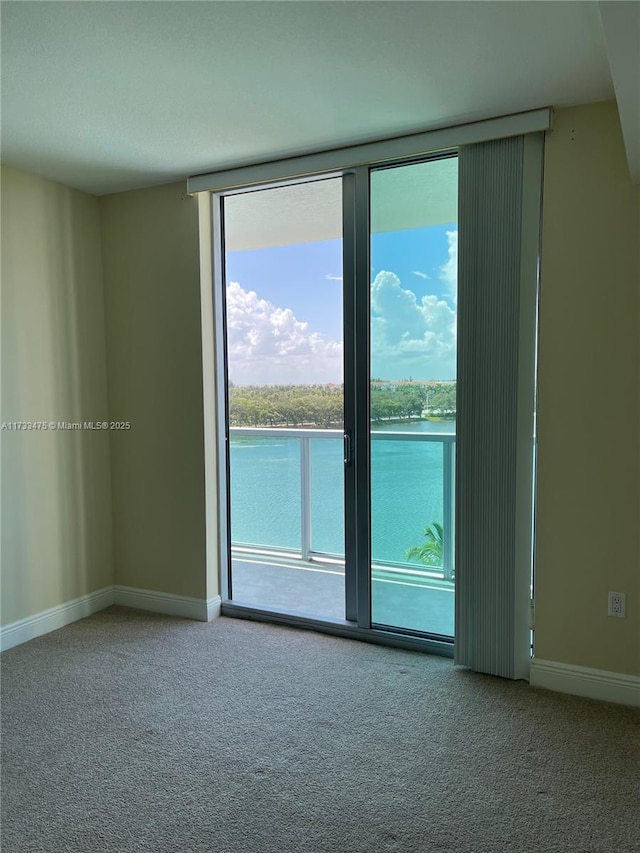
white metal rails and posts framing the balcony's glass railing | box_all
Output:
[229,427,455,580]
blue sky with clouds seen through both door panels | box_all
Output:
[226,223,457,384]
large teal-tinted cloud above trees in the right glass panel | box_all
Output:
[371,272,456,379]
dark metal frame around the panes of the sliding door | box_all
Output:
[212,160,455,657]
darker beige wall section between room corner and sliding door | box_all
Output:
[100,184,207,598]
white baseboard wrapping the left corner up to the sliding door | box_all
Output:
[0,586,221,651]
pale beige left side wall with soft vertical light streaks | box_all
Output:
[2,167,113,624]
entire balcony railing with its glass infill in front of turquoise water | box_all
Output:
[230,427,455,581]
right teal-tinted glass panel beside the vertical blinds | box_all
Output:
[370,157,458,636]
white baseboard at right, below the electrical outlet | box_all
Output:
[529,658,640,708]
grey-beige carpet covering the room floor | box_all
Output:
[2,608,640,853]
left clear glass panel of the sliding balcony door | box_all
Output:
[223,178,345,619]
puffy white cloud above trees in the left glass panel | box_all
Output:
[227,281,342,385]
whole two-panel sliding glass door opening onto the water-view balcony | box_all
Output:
[220,155,457,640]
